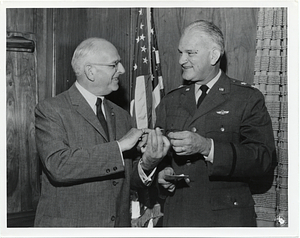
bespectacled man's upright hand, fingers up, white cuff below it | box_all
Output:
[141,128,170,171]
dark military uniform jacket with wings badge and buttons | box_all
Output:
[157,73,275,227]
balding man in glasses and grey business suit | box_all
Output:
[35,38,170,227]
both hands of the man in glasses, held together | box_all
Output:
[118,128,170,171]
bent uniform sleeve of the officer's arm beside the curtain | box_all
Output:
[209,90,276,177]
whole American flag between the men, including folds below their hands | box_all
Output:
[130,8,164,227]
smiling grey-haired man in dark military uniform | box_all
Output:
[157,21,275,227]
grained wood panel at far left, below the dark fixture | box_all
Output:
[6,34,40,213]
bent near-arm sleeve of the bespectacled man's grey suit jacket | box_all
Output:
[35,100,124,184]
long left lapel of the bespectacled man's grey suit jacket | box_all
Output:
[69,84,108,141]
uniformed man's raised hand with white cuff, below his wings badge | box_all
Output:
[168,131,211,156]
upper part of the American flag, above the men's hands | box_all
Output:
[130,8,164,129]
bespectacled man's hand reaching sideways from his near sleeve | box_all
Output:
[119,128,151,152]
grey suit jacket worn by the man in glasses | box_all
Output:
[35,85,142,227]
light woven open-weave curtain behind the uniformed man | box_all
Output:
[253,8,288,227]
